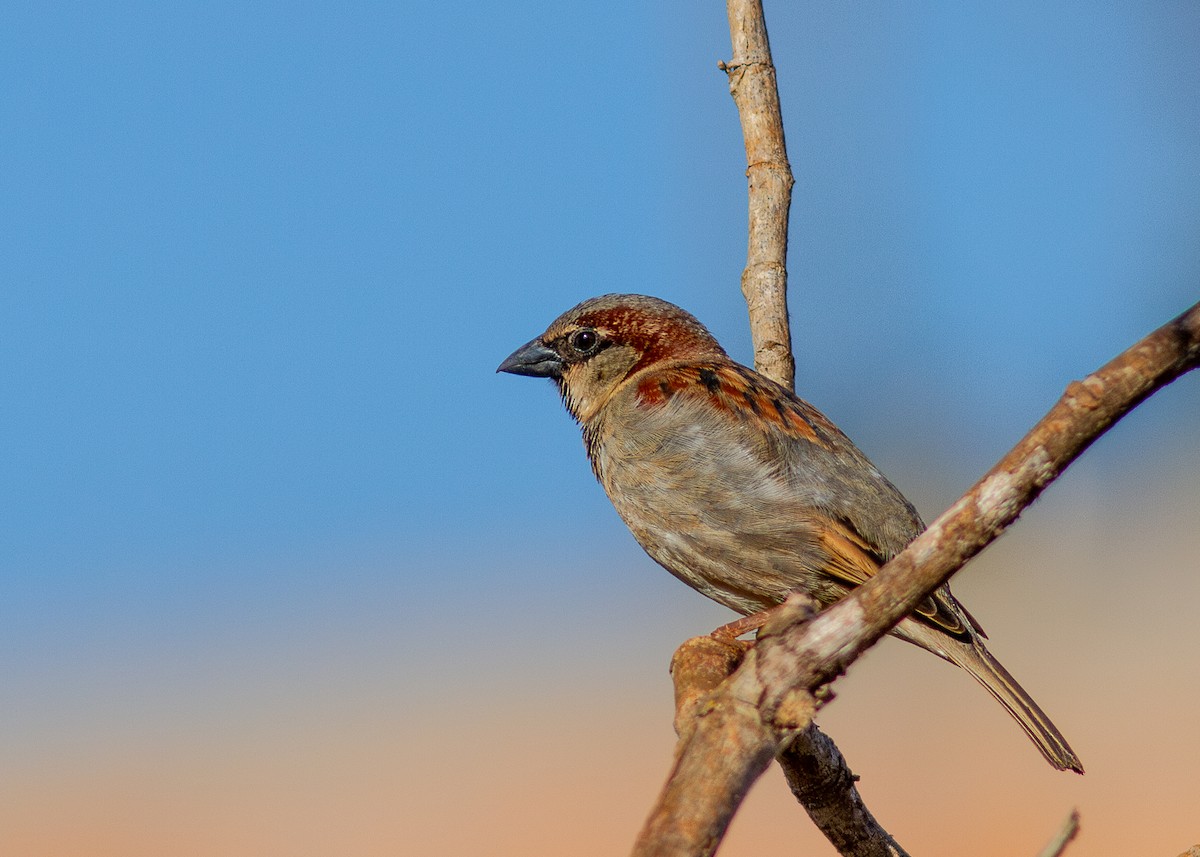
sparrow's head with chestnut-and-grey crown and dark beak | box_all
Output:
[497,294,725,421]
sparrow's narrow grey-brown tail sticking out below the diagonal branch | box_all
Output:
[896,619,1084,774]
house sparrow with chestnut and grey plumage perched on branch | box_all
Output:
[497,294,1084,773]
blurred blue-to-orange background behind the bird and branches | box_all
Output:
[0,0,1200,857]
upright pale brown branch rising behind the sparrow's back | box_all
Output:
[718,0,796,390]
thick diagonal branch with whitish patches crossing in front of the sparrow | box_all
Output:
[634,297,1200,857]
